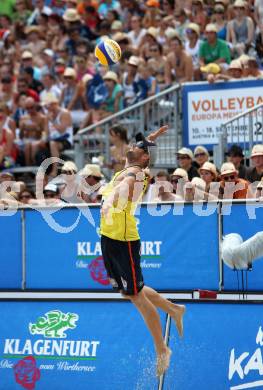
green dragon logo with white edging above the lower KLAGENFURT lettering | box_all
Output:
[29,310,79,338]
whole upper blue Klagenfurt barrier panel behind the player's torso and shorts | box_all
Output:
[26,205,219,291]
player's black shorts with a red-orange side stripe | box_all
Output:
[101,236,144,295]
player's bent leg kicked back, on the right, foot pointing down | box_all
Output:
[143,286,185,337]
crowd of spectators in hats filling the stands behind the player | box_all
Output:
[0,0,263,204]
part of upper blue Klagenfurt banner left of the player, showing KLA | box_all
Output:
[26,207,111,290]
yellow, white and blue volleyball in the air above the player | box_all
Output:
[95,39,121,66]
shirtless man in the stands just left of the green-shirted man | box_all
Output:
[165,32,193,85]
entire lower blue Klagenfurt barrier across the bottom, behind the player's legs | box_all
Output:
[0,300,263,390]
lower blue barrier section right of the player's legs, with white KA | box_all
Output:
[163,302,263,390]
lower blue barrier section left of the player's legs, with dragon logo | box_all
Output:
[0,301,165,390]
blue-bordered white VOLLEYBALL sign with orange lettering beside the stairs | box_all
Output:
[182,79,263,150]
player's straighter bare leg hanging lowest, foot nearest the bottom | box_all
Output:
[126,288,172,376]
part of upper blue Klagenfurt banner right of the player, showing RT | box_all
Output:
[137,204,219,291]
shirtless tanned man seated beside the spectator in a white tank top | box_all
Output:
[19,97,47,165]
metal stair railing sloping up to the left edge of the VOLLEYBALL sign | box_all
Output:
[74,84,182,174]
